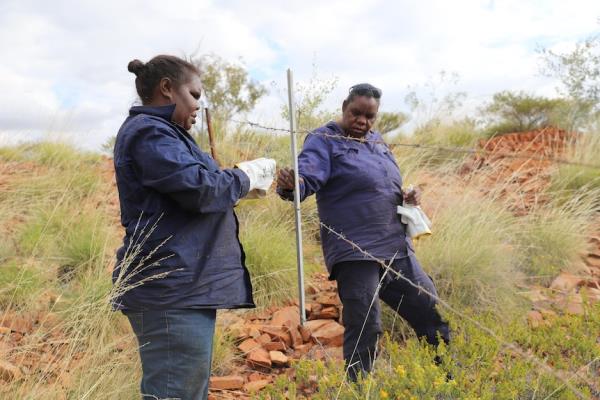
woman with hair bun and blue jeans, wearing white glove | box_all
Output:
[113,55,275,400]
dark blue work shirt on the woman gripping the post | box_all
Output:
[279,122,412,273]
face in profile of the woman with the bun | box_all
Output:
[171,74,202,131]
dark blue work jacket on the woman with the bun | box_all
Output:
[113,105,254,311]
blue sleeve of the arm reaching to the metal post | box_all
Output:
[278,134,331,201]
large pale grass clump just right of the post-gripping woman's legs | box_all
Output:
[416,187,519,314]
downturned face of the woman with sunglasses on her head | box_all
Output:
[341,96,379,138]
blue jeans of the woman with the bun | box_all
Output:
[124,309,216,400]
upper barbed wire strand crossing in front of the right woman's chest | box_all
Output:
[229,119,600,170]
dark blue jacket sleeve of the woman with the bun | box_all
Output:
[131,125,250,213]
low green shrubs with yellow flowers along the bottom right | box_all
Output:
[259,306,600,400]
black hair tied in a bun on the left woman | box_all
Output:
[127,55,200,104]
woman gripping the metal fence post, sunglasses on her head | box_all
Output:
[277,83,450,380]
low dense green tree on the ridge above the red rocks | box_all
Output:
[482,90,569,136]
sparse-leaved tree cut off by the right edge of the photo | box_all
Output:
[539,34,600,130]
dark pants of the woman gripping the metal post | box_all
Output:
[333,255,450,380]
